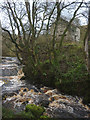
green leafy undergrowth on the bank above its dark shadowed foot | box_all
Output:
[24,44,88,87]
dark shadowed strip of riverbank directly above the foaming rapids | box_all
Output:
[21,76,90,106]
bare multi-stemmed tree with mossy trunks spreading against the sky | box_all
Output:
[1,0,83,65]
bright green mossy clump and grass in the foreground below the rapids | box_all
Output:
[2,104,48,120]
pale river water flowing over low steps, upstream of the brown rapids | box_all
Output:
[0,57,37,94]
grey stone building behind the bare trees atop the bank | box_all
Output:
[51,18,80,41]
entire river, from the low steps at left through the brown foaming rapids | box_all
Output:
[1,58,90,118]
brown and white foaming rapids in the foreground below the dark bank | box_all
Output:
[3,87,90,118]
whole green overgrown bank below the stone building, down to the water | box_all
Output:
[24,41,90,104]
